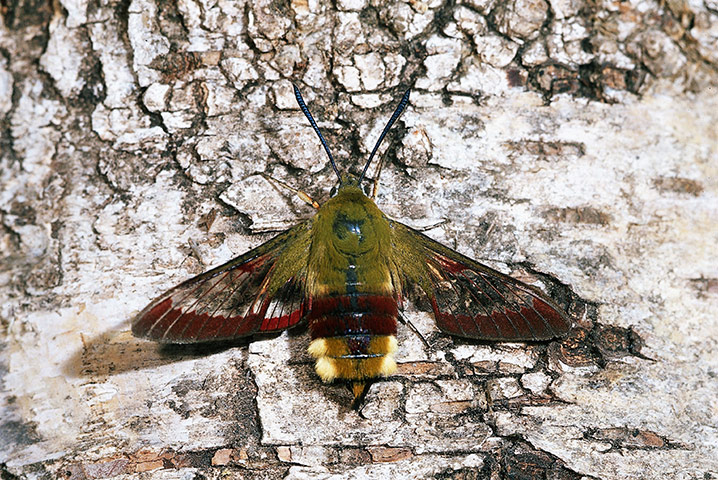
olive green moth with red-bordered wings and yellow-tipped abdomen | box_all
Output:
[132,85,572,408]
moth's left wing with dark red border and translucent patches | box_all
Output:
[132,221,311,343]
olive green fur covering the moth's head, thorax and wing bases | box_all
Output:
[268,176,438,302]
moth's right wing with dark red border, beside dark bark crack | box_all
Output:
[392,222,572,341]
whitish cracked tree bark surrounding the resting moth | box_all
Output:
[0,0,718,479]
